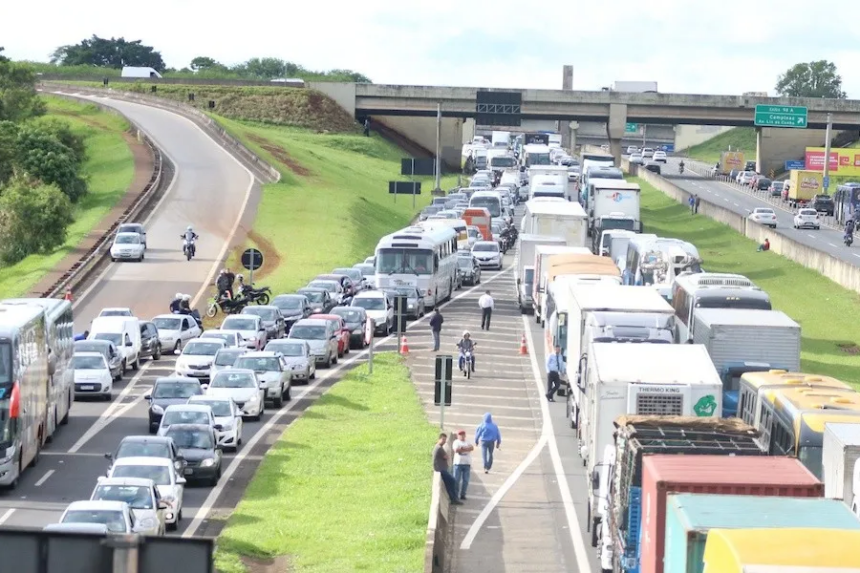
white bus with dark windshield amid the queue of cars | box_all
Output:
[375,227,457,308]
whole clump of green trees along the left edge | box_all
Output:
[0,47,87,264]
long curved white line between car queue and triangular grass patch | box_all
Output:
[182,267,512,537]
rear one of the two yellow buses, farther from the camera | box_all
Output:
[737,370,851,428]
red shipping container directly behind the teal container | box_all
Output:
[639,454,824,573]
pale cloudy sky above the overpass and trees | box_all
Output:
[6,0,860,98]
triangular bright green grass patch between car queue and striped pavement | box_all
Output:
[216,353,437,573]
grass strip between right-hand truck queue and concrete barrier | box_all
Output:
[632,178,860,389]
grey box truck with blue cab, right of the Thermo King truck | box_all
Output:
[692,308,801,417]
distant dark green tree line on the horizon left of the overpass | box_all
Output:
[50,35,372,83]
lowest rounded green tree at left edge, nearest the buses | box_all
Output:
[0,175,72,264]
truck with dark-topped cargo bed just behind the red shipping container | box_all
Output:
[586,415,767,573]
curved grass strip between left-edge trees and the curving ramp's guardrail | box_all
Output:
[0,96,134,297]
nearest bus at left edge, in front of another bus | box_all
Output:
[0,305,50,488]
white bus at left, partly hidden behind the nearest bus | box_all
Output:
[0,298,75,441]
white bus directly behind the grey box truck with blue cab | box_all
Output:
[668,272,773,342]
